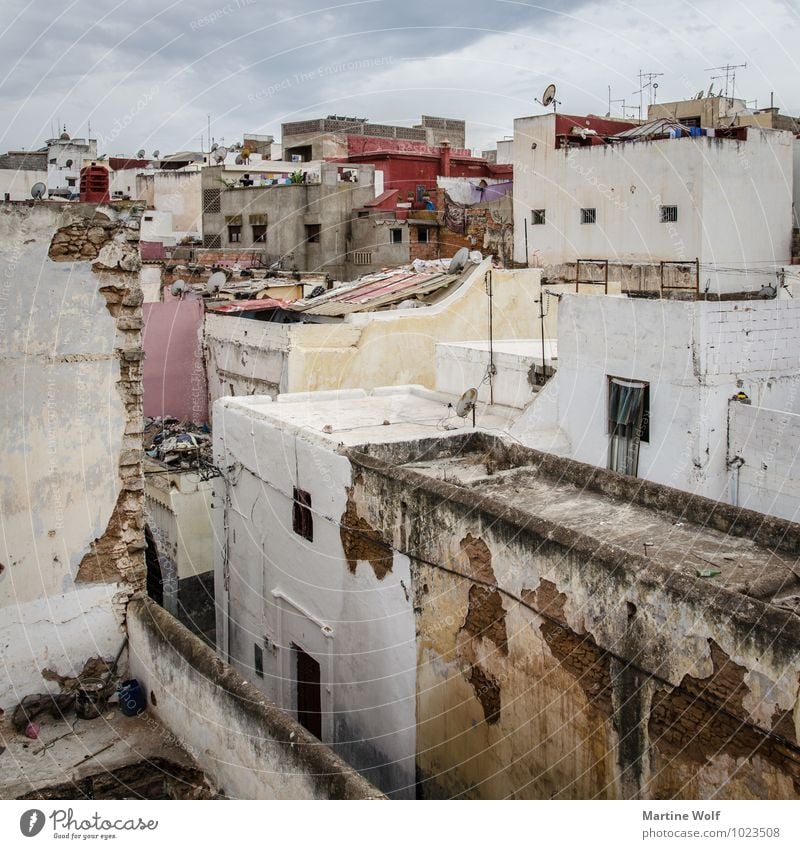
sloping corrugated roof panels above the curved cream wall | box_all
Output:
[288,268,460,316]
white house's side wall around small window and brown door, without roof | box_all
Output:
[213,399,416,798]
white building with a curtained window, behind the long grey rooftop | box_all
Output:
[512,295,800,521]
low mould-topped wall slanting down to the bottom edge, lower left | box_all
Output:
[128,598,382,799]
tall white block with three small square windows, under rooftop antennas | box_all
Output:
[514,114,793,294]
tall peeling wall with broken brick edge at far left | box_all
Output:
[0,204,144,709]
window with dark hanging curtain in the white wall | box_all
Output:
[608,377,650,475]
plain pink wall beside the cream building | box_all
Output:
[142,298,208,424]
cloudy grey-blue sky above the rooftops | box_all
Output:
[0,0,800,155]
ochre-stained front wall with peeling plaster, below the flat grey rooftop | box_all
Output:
[348,449,800,799]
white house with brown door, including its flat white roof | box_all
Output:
[212,387,508,798]
